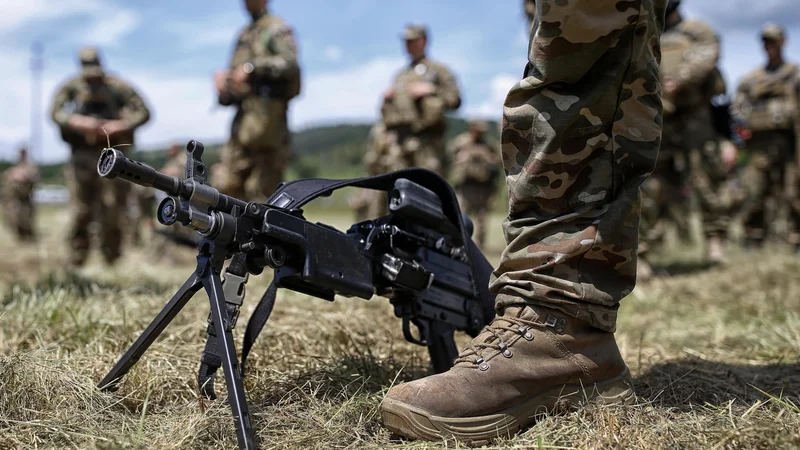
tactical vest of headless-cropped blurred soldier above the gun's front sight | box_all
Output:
[230,14,301,101]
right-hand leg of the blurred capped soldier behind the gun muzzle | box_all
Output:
[100,179,131,264]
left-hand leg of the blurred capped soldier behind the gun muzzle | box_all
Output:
[65,149,102,266]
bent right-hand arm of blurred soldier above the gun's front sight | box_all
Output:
[250,24,300,79]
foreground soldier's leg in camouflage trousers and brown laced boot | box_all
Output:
[381,0,666,440]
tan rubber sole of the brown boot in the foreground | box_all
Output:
[380,368,636,445]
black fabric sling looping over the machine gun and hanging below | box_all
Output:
[197,169,492,399]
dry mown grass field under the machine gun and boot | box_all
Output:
[0,206,800,449]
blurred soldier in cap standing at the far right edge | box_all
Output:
[734,24,800,245]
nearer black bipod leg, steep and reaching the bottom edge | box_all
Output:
[202,267,256,449]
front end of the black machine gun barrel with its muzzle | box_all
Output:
[97,148,185,196]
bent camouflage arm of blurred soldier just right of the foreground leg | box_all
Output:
[674,22,720,91]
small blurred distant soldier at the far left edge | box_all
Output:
[3,147,39,241]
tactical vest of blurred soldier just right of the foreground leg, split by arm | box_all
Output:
[659,25,725,117]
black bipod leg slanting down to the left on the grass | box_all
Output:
[98,273,202,391]
